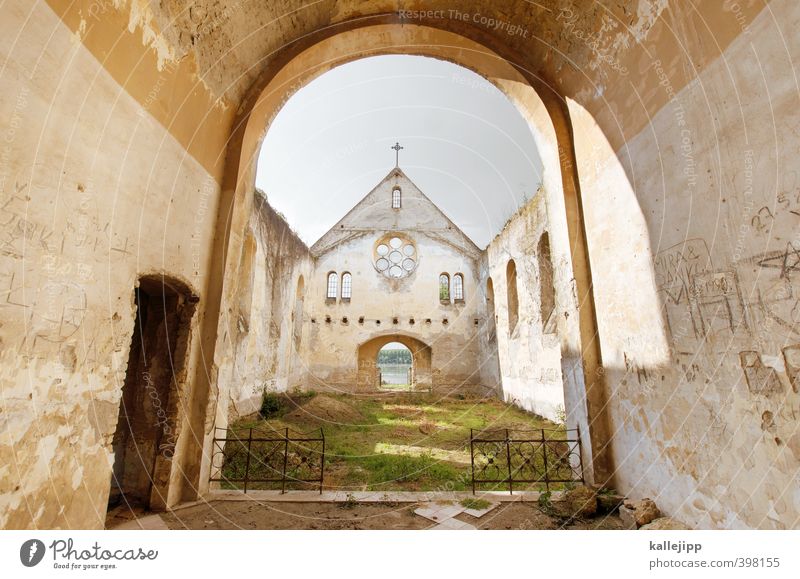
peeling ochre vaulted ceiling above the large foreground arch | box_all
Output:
[123,0,763,154]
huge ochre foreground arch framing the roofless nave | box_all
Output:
[200,22,613,492]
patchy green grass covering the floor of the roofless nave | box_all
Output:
[226,394,558,491]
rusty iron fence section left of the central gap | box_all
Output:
[209,428,325,494]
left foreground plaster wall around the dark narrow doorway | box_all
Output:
[0,1,219,528]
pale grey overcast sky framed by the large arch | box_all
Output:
[256,56,541,248]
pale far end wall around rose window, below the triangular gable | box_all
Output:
[306,231,482,392]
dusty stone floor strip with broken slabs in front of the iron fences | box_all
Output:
[108,491,622,530]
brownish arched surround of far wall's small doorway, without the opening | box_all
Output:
[356,334,433,391]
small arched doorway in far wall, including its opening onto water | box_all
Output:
[358,334,433,391]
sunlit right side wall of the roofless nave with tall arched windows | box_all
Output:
[482,190,574,420]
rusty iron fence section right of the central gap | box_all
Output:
[469,428,583,494]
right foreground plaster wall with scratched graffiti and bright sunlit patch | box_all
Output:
[570,1,800,528]
